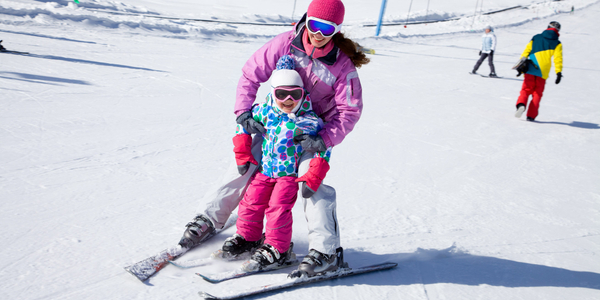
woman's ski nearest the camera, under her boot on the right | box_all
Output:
[199,263,398,300]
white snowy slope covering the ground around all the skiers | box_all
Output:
[0,0,600,300]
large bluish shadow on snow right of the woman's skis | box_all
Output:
[332,246,600,290]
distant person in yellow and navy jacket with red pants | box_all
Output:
[515,21,562,121]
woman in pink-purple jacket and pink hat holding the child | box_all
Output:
[180,0,369,276]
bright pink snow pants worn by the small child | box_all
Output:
[236,173,298,253]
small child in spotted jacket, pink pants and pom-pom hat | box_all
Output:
[222,55,331,271]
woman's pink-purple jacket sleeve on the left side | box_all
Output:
[234,31,294,115]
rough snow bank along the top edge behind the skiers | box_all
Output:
[0,0,599,39]
